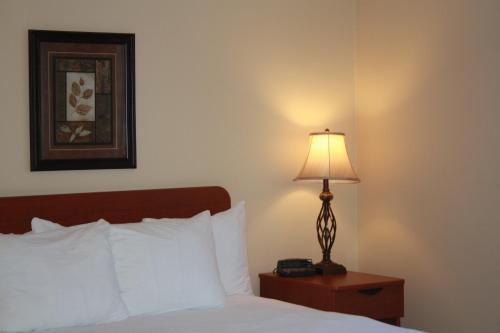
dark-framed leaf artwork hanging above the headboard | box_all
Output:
[29,30,136,171]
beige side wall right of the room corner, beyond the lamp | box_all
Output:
[356,0,500,333]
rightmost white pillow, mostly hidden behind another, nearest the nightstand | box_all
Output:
[143,201,253,295]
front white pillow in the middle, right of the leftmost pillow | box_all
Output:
[32,211,225,315]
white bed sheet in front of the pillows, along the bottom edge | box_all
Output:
[44,295,417,333]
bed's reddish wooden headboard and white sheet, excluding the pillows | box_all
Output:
[0,187,422,333]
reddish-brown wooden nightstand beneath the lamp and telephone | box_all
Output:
[259,272,404,326]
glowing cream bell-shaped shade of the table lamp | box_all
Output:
[295,129,360,183]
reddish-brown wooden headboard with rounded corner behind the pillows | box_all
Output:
[0,186,231,234]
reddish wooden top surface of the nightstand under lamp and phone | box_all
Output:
[259,272,404,290]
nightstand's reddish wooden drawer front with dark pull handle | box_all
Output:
[333,284,404,319]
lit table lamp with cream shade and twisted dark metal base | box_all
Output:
[294,129,360,275]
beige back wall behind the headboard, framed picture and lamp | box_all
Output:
[0,0,357,287]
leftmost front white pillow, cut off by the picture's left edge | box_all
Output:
[0,222,128,332]
